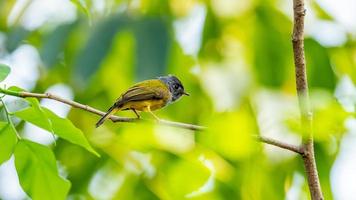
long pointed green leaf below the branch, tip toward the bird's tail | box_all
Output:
[14,107,99,156]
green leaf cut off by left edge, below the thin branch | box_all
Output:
[0,122,17,164]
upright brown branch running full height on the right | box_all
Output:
[292,0,323,200]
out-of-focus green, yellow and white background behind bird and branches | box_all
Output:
[0,0,356,200]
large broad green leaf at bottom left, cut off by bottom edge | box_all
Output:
[15,140,70,200]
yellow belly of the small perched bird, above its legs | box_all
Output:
[122,99,167,112]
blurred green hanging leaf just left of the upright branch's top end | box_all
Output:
[252,5,292,87]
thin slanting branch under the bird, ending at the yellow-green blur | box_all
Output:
[0,88,206,131]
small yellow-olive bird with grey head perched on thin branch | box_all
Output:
[95,75,189,128]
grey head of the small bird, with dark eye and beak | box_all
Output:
[158,75,189,102]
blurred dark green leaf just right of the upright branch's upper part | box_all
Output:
[305,39,336,90]
